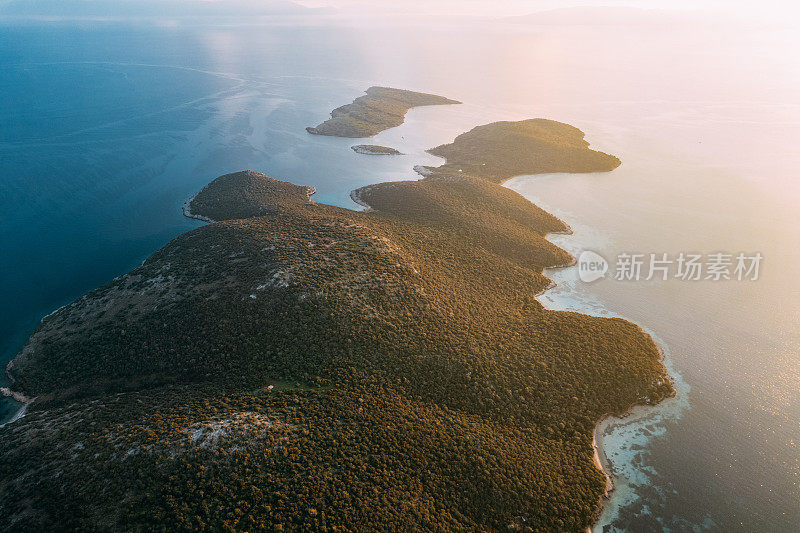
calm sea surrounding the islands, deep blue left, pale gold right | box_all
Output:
[0,12,800,532]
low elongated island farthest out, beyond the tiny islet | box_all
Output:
[306,87,461,137]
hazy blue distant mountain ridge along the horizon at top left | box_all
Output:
[0,0,316,19]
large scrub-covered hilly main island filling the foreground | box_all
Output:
[0,118,672,531]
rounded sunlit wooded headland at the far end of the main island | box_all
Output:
[425,118,620,183]
